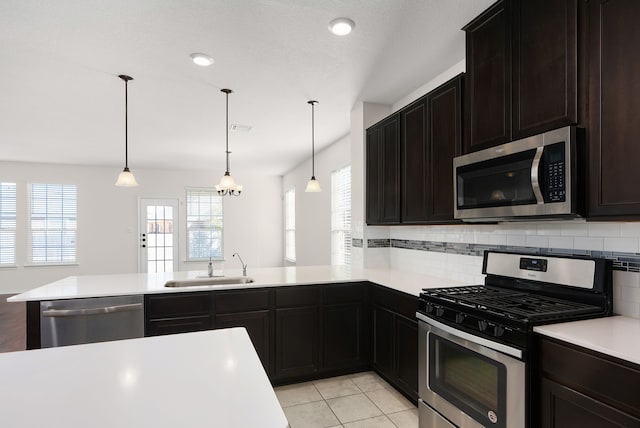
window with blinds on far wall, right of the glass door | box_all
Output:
[187,189,223,260]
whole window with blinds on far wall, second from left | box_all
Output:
[29,184,77,264]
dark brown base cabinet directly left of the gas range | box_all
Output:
[371,285,418,402]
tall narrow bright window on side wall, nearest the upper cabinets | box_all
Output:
[331,165,351,265]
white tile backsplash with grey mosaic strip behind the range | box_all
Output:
[354,221,640,318]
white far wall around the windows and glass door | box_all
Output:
[0,162,283,294]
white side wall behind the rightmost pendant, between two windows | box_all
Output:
[282,135,351,266]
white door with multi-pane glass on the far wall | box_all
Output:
[138,198,179,273]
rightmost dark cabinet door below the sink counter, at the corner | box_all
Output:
[322,303,366,370]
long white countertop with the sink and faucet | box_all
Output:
[7,266,467,302]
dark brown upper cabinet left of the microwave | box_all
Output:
[366,74,463,225]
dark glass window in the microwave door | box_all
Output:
[456,149,537,209]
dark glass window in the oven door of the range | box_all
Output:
[429,334,507,427]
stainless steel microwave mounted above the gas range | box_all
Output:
[453,126,580,222]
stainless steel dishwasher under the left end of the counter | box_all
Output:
[40,296,144,348]
